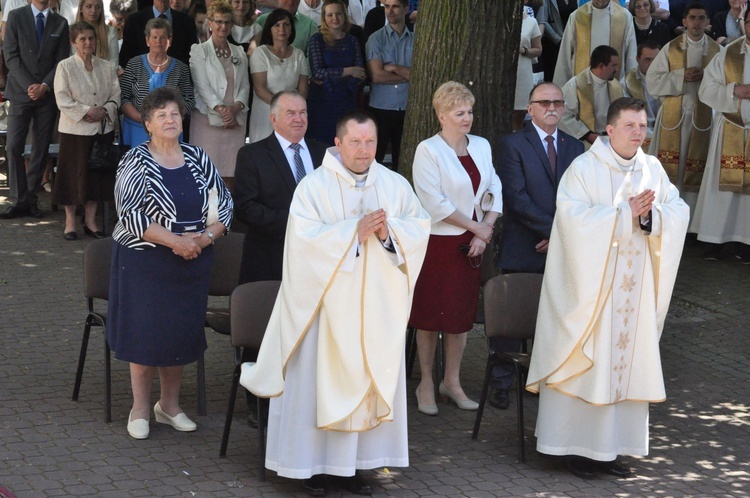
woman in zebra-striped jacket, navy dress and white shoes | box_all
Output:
[107,87,233,439]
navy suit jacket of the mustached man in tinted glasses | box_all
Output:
[497,124,584,273]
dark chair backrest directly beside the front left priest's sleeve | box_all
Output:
[229,280,281,351]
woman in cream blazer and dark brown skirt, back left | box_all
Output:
[52,22,120,240]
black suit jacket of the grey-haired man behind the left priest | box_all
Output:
[234,133,327,284]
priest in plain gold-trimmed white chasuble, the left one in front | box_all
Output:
[240,111,430,494]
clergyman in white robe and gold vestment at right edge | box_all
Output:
[690,19,750,265]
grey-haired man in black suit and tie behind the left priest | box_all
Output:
[234,91,327,426]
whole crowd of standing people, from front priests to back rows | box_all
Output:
[2,0,750,495]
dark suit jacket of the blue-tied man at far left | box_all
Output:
[3,5,70,102]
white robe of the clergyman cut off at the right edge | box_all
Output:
[690,38,750,244]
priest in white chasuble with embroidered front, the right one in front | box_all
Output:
[527,98,689,478]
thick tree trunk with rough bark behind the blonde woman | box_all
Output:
[399,0,523,180]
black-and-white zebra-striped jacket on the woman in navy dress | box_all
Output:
[112,143,234,250]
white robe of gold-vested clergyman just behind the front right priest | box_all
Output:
[646,34,708,212]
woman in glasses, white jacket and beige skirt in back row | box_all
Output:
[190,1,250,191]
